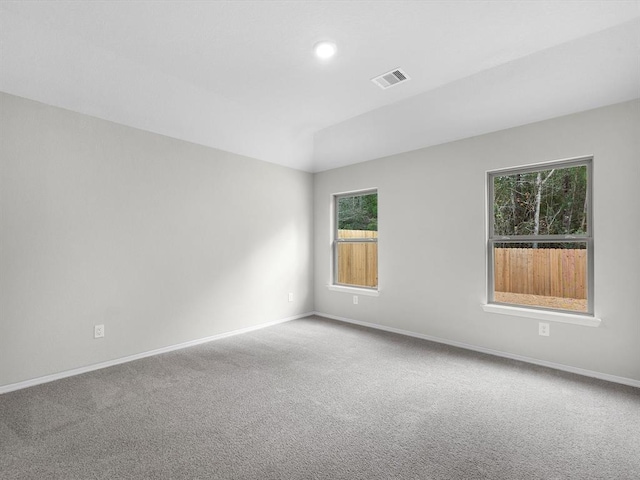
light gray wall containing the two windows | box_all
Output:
[314,101,640,380]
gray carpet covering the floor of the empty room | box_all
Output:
[0,317,640,480]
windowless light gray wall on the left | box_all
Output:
[0,93,313,386]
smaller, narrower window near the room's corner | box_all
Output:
[333,190,378,289]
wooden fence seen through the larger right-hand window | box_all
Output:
[493,248,587,299]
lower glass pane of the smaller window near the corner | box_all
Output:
[337,242,378,287]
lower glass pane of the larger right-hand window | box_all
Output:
[493,242,588,312]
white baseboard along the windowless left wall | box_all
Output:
[0,312,313,395]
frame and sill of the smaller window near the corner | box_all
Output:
[328,188,380,296]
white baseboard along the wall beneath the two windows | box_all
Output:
[314,312,640,388]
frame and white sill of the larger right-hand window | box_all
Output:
[483,156,601,326]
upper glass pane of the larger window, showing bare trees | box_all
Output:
[493,165,588,236]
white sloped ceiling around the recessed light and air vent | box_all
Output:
[0,0,640,171]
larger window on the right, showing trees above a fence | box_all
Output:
[488,158,593,314]
